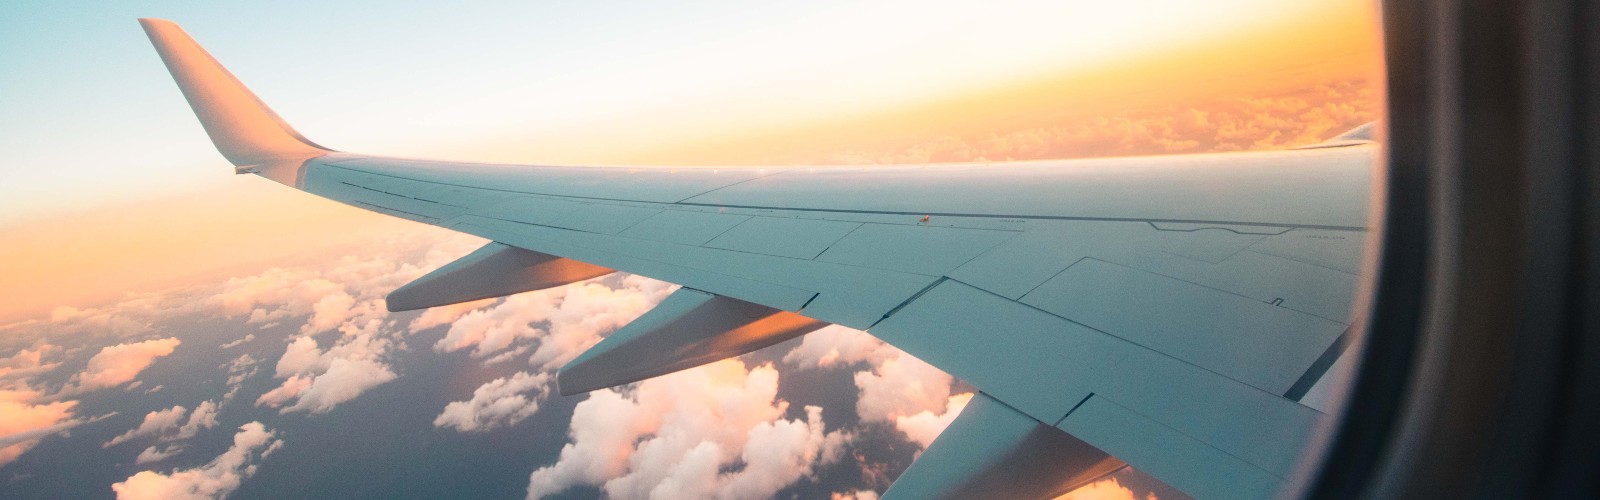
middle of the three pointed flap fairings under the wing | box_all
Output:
[555,288,827,396]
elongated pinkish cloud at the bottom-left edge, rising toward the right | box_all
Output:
[110,421,283,500]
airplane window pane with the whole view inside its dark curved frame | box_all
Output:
[0,0,1414,500]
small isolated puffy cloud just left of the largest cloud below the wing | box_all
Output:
[434,372,550,433]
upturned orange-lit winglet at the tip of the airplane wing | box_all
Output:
[139,19,331,171]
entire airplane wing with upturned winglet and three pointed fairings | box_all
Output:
[141,19,1376,498]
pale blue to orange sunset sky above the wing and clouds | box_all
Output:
[0,0,1378,321]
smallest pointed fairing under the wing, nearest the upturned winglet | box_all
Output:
[386,242,614,311]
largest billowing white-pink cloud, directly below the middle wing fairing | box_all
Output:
[528,359,851,498]
